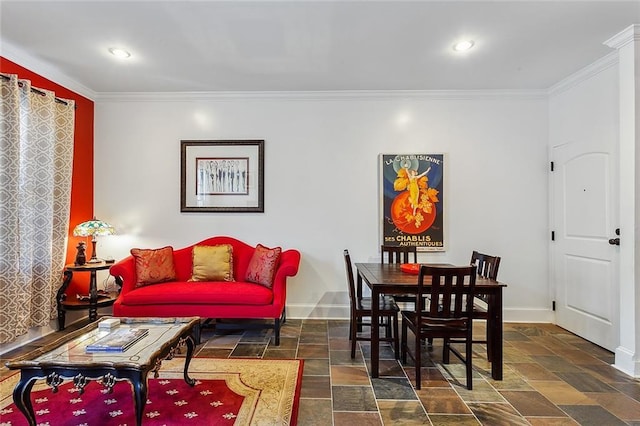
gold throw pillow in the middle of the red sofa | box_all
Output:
[189,244,234,281]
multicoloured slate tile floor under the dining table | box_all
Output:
[0,319,640,426]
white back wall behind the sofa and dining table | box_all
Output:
[95,92,551,321]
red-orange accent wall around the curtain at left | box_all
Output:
[0,56,94,296]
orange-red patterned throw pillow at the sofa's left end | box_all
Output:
[131,246,176,287]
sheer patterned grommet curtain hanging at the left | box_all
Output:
[0,75,75,343]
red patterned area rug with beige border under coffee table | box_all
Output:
[0,358,303,426]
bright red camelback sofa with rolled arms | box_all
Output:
[110,236,300,345]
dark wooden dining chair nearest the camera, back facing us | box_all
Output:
[400,265,476,390]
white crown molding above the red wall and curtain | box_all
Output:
[0,40,96,100]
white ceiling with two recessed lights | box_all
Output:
[0,0,640,93]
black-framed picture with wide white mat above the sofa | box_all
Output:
[180,140,264,213]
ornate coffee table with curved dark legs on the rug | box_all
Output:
[6,317,200,425]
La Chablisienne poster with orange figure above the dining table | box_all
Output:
[380,154,446,251]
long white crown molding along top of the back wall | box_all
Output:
[95,90,547,102]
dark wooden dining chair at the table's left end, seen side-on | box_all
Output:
[343,250,400,359]
